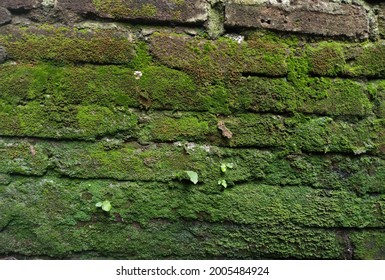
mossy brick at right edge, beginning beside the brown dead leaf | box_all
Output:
[224,114,384,154]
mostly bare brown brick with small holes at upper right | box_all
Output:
[225,0,370,38]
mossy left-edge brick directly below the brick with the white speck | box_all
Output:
[0,101,137,140]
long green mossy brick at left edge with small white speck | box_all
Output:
[0,62,201,111]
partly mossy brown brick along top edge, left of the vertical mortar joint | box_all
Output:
[57,0,208,23]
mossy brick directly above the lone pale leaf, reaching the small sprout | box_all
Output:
[41,139,273,184]
